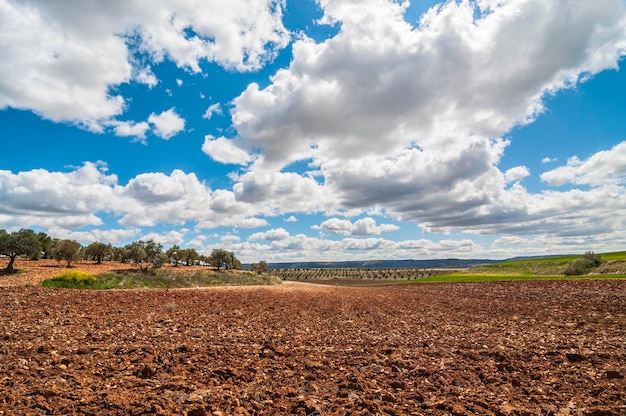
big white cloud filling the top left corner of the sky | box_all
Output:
[0,0,289,131]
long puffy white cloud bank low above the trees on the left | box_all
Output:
[0,162,268,237]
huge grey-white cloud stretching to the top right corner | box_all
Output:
[232,0,626,167]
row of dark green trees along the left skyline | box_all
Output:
[0,228,242,273]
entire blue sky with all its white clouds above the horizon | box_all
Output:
[0,0,626,262]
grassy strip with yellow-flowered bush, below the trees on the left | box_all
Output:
[41,270,281,289]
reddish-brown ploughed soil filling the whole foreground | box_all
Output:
[0,262,626,416]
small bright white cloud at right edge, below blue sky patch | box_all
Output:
[541,142,626,186]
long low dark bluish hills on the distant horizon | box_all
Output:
[260,259,502,269]
